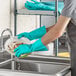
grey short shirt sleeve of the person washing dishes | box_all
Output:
[61,0,76,19]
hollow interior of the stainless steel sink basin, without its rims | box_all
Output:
[17,62,69,75]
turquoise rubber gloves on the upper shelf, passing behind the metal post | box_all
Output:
[25,0,64,15]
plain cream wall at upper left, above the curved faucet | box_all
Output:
[0,0,10,35]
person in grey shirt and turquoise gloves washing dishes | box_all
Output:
[14,0,76,76]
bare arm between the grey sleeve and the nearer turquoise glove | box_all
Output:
[41,16,70,45]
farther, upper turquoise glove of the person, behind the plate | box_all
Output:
[17,26,46,40]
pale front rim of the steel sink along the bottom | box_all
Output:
[0,69,71,76]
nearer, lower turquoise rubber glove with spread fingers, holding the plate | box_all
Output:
[14,39,48,57]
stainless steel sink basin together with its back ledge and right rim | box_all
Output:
[15,55,70,76]
